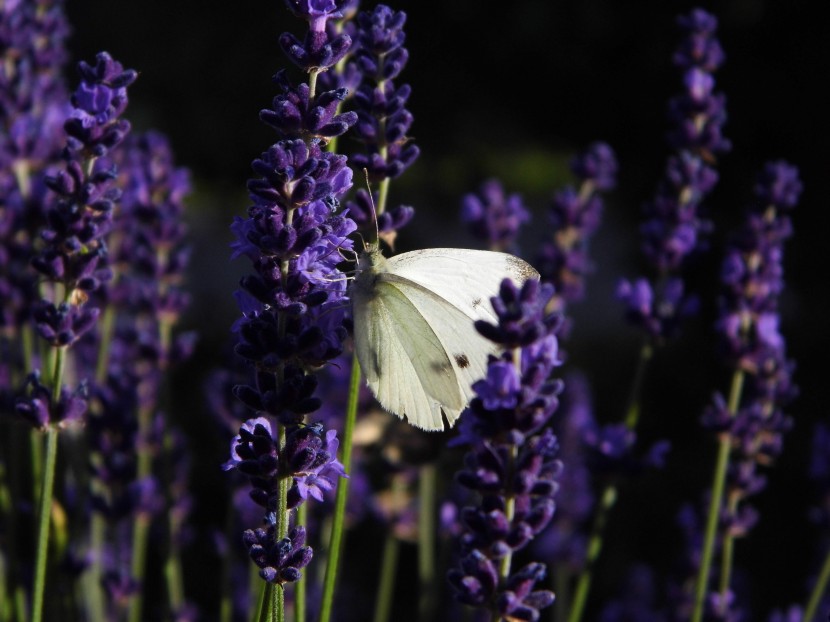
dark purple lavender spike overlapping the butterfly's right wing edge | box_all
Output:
[448,280,561,620]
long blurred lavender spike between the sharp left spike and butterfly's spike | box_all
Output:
[81,133,194,615]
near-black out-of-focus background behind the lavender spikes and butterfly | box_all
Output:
[60,0,830,619]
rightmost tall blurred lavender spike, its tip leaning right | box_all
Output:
[698,162,801,619]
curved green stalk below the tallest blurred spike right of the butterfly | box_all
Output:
[568,342,654,622]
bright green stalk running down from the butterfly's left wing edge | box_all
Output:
[319,356,360,622]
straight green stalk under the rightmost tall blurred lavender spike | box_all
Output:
[691,370,744,622]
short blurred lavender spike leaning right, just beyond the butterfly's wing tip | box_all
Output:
[535,142,617,310]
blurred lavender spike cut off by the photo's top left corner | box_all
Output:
[0,0,71,346]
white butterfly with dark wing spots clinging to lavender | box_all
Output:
[350,245,539,430]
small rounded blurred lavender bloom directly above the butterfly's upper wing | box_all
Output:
[461,179,530,251]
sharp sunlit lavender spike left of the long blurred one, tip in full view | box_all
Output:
[14,52,137,423]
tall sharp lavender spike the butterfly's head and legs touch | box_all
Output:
[225,0,357,584]
